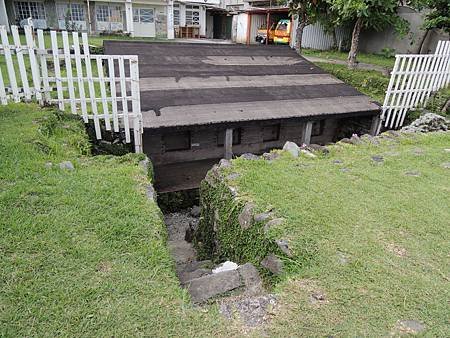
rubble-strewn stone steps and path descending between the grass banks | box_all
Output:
[164,206,276,327]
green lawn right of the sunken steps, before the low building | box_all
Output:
[221,133,450,337]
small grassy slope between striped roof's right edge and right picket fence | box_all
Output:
[316,62,389,103]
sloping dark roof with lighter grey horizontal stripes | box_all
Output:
[104,41,379,128]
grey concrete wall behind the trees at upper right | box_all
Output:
[359,7,449,54]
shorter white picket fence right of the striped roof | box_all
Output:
[380,41,450,128]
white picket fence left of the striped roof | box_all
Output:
[0,26,143,152]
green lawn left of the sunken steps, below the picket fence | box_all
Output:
[0,104,235,337]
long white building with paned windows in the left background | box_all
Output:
[0,0,220,38]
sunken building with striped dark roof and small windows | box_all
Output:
[105,41,380,192]
